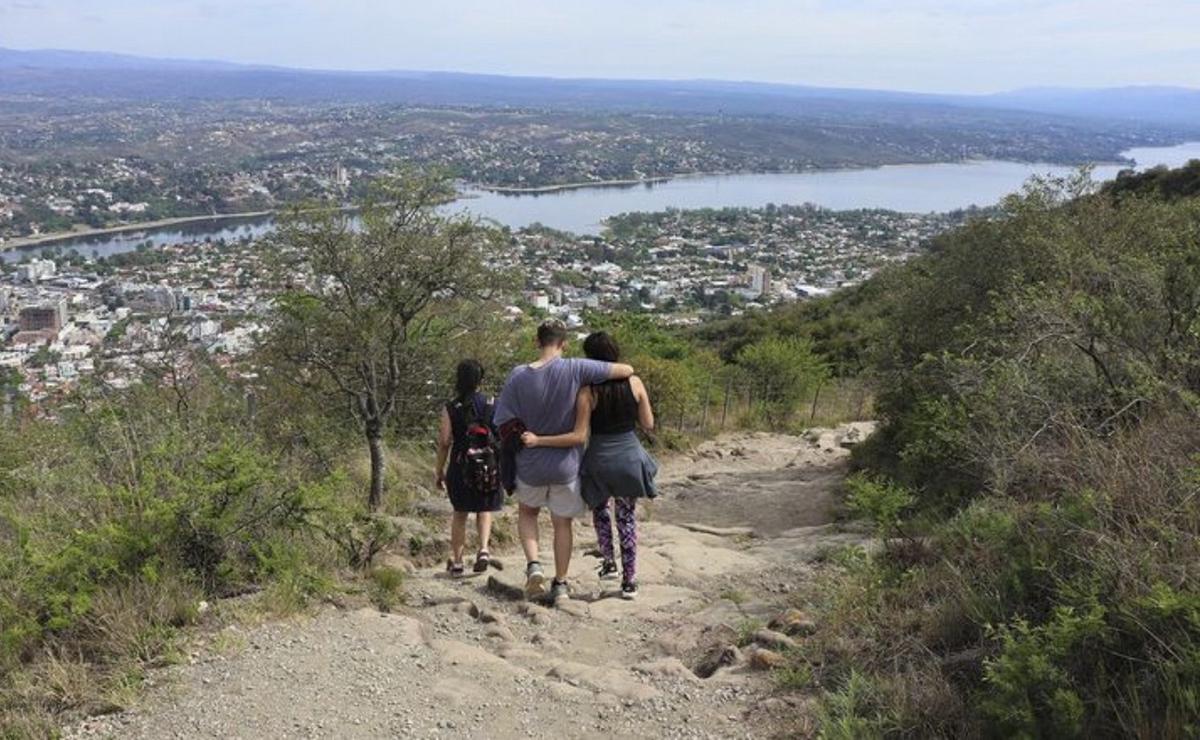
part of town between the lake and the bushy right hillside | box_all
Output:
[512,205,971,324]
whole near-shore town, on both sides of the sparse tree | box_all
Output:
[0,200,967,404]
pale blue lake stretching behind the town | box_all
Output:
[11,142,1200,261]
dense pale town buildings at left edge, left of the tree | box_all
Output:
[0,240,280,404]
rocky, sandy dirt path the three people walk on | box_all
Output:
[67,429,873,739]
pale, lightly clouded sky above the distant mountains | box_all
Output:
[0,0,1200,92]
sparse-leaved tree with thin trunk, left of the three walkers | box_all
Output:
[269,172,496,511]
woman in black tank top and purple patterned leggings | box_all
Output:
[522,331,659,598]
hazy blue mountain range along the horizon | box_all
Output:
[0,48,1200,130]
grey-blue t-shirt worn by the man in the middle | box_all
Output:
[496,357,612,486]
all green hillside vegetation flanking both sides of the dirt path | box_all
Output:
[0,166,1200,738]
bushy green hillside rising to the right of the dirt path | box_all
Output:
[729,163,1200,738]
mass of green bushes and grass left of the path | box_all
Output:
[0,366,352,734]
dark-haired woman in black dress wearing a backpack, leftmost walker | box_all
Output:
[434,360,504,578]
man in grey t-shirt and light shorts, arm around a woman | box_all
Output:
[496,320,634,601]
